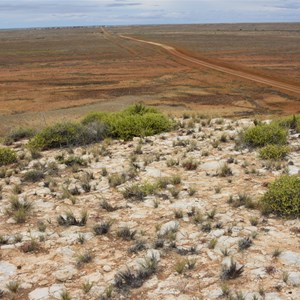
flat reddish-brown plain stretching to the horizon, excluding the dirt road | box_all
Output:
[0,23,300,134]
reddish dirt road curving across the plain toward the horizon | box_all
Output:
[120,35,300,95]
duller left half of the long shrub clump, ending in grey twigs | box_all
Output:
[28,122,106,150]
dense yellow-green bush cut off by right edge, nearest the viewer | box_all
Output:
[260,175,300,218]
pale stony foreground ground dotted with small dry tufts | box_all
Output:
[0,118,300,300]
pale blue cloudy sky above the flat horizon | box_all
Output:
[0,0,300,28]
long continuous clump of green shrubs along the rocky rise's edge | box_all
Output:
[28,104,173,150]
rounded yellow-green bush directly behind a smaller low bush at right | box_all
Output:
[242,123,288,147]
